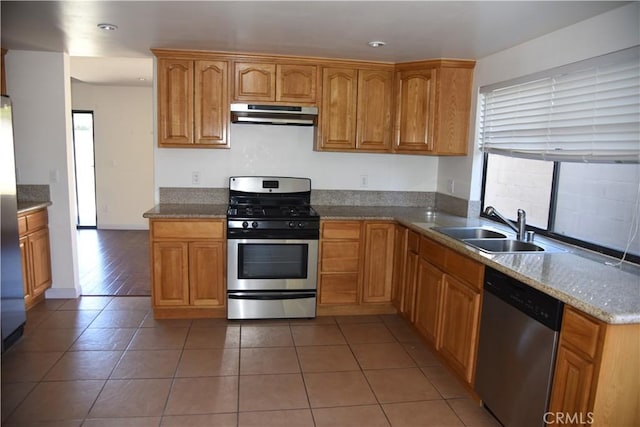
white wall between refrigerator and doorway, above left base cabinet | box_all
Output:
[6,51,80,298]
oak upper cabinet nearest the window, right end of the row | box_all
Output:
[394,60,475,155]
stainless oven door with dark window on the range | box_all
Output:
[227,239,318,292]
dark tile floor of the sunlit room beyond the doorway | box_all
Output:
[77,229,151,296]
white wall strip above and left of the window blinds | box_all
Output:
[437,2,640,204]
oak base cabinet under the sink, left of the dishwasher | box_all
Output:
[414,236,484,384]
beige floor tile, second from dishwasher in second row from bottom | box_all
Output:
[364,368,442,403]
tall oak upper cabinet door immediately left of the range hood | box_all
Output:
[194,61,229,147]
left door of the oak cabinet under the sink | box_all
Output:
[415,259,444,349]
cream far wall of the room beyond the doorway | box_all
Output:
[71,83,154,229]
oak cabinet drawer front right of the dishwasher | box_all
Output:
[562,307,602,359]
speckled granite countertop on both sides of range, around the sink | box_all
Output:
[143,204,640,324]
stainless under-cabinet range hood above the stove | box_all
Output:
[231,104,318,126]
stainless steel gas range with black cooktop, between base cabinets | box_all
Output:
[227,176,320,319]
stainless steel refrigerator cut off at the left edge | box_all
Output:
[0,95,26,353]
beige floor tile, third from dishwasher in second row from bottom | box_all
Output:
[304,371,377,408]
